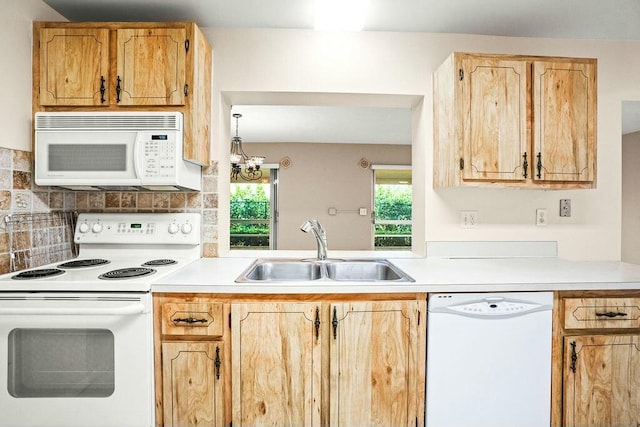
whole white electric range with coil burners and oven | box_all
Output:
[0,213,200,427]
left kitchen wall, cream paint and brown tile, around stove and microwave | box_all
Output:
[0,0,218,273]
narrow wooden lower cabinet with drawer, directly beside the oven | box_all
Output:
[154,294,230,427]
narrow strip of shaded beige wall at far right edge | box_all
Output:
[622,132,640,264]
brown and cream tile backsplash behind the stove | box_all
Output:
[0,148,218,273]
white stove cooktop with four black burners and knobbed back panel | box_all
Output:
[0,213,200,292]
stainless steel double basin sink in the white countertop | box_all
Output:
[236,258,414,283]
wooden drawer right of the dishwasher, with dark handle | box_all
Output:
[564,298,640,329]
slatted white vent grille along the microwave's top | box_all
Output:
[35,112,182,131]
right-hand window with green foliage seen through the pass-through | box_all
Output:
[372,165,412,250]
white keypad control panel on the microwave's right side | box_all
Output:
[143,134,178,178]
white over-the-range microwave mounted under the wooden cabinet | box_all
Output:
[35,112,202,191]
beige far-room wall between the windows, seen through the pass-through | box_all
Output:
[243,143,411,250]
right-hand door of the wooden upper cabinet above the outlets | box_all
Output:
[533,61,596,182]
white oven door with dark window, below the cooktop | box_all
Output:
[0,293,154,427]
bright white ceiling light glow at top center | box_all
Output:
[315,0,369,31]
